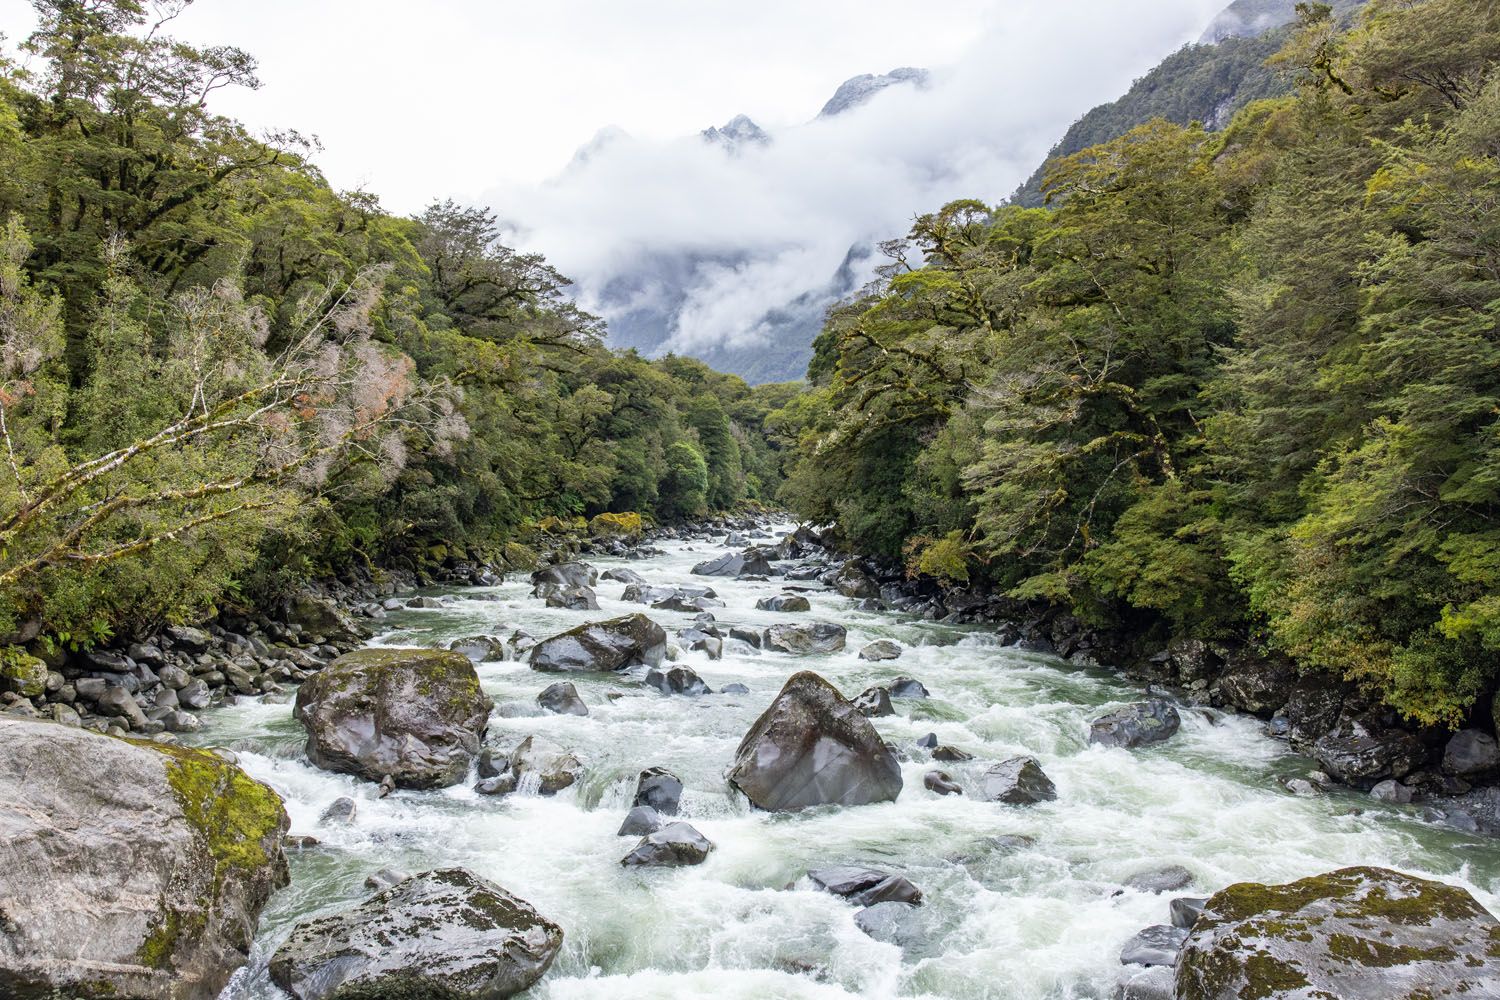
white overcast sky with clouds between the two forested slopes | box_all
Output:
[0,0,1229,359]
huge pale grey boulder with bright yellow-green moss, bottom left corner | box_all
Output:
[0,717,287,1000]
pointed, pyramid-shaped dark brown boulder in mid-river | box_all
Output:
[728,670,902,813]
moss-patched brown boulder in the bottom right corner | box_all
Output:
[1176,868,1500,1000]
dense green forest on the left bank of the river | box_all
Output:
[0,0,795,645]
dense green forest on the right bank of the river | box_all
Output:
[771,0,1500,723]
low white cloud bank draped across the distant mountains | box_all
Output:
[488,0,1223,370]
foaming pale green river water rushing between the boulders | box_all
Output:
[208,527,1500,1000]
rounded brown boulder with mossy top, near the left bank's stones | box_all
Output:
[294,649,494,789]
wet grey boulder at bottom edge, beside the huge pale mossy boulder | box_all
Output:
[270,868,563,1000]
